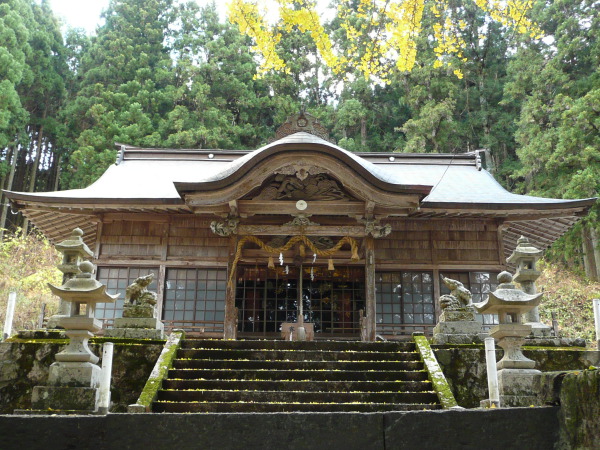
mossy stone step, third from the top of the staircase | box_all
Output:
[173,359,423,370]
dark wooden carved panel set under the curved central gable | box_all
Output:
[254,173,350,201]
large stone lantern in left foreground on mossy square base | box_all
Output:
[32,261,119,413]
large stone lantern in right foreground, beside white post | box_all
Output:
[473,272,543,406]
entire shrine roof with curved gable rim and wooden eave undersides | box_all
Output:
[6,132,595,255]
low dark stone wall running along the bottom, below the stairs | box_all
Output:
[0,407,558,450]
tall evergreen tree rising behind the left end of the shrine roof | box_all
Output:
[64,0,174,187]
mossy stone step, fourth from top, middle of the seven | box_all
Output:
[168,368,428,381]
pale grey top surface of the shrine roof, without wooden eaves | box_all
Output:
[3,133,596,207]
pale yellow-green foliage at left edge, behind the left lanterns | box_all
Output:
[0,232,62,330]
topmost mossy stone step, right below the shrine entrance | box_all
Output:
[181,339,415,352]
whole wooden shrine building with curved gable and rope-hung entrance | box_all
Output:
[7,114,595,340]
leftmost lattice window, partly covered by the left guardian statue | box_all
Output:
[95,267,158,328]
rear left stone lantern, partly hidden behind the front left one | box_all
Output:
[47,228,94,328]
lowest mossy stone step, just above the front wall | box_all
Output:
[152,402,442,413]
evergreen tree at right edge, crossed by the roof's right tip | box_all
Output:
[506,0,600,279]
